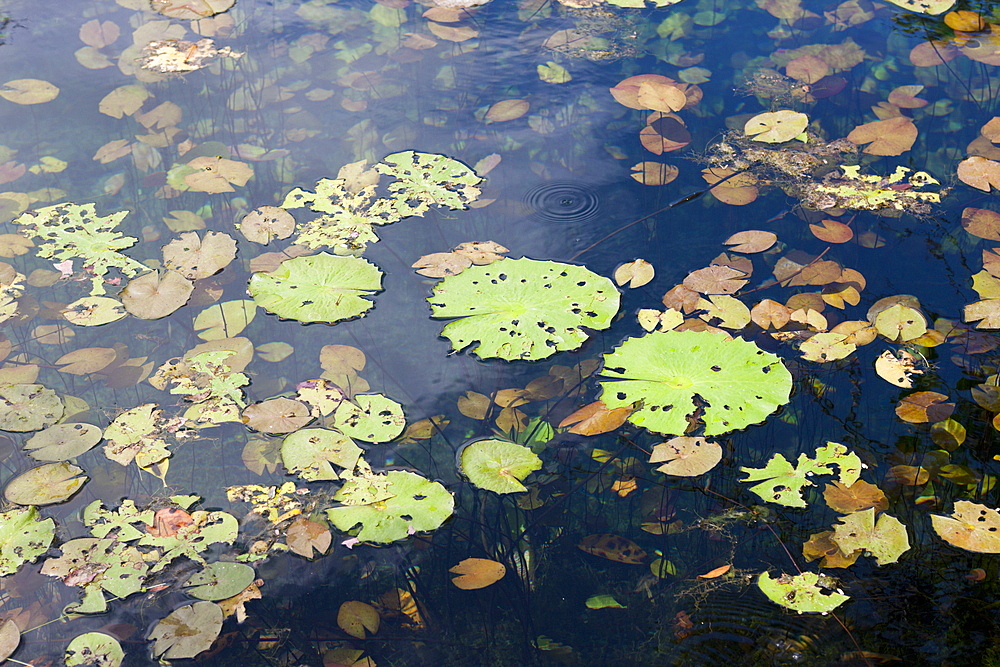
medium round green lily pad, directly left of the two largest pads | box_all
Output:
[249,253,382,324]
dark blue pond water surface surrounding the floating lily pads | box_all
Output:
[0,0,1000,666]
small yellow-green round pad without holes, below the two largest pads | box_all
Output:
[458,438,542,493]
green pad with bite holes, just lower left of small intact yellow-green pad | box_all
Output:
[326,470,455,544]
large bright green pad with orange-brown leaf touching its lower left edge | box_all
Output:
[596,330,792,435]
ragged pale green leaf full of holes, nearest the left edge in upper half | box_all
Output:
[14,204,149,296]
